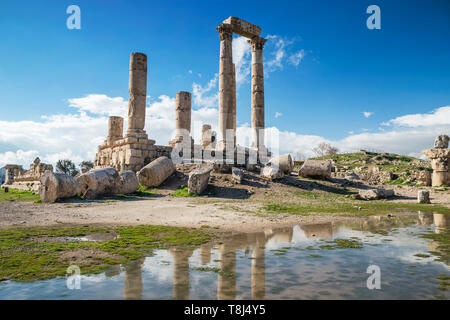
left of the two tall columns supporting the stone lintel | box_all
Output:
[217,24,233,149]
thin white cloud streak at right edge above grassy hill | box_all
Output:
[383,106,450,130]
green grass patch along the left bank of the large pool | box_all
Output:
[0,225,213,281]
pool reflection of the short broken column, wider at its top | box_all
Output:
[169,248,192,300]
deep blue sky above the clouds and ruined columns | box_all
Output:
[0,0,450,164]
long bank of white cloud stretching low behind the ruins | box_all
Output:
[0,90,450,168]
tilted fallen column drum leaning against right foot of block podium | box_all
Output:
[137,157,175,187]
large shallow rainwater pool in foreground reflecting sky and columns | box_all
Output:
[0,215,450,299]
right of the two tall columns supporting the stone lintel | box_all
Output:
[248,36,267,150]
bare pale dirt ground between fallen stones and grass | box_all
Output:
[0,166,450,232]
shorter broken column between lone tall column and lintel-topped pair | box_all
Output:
[169,91,191,147]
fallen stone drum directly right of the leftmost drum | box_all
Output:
[77,167,120,196]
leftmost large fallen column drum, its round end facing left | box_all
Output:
[39,170,80,203]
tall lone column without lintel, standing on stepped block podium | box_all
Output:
[127,52,148,139]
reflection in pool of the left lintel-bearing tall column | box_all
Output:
[217,244,236,300]
